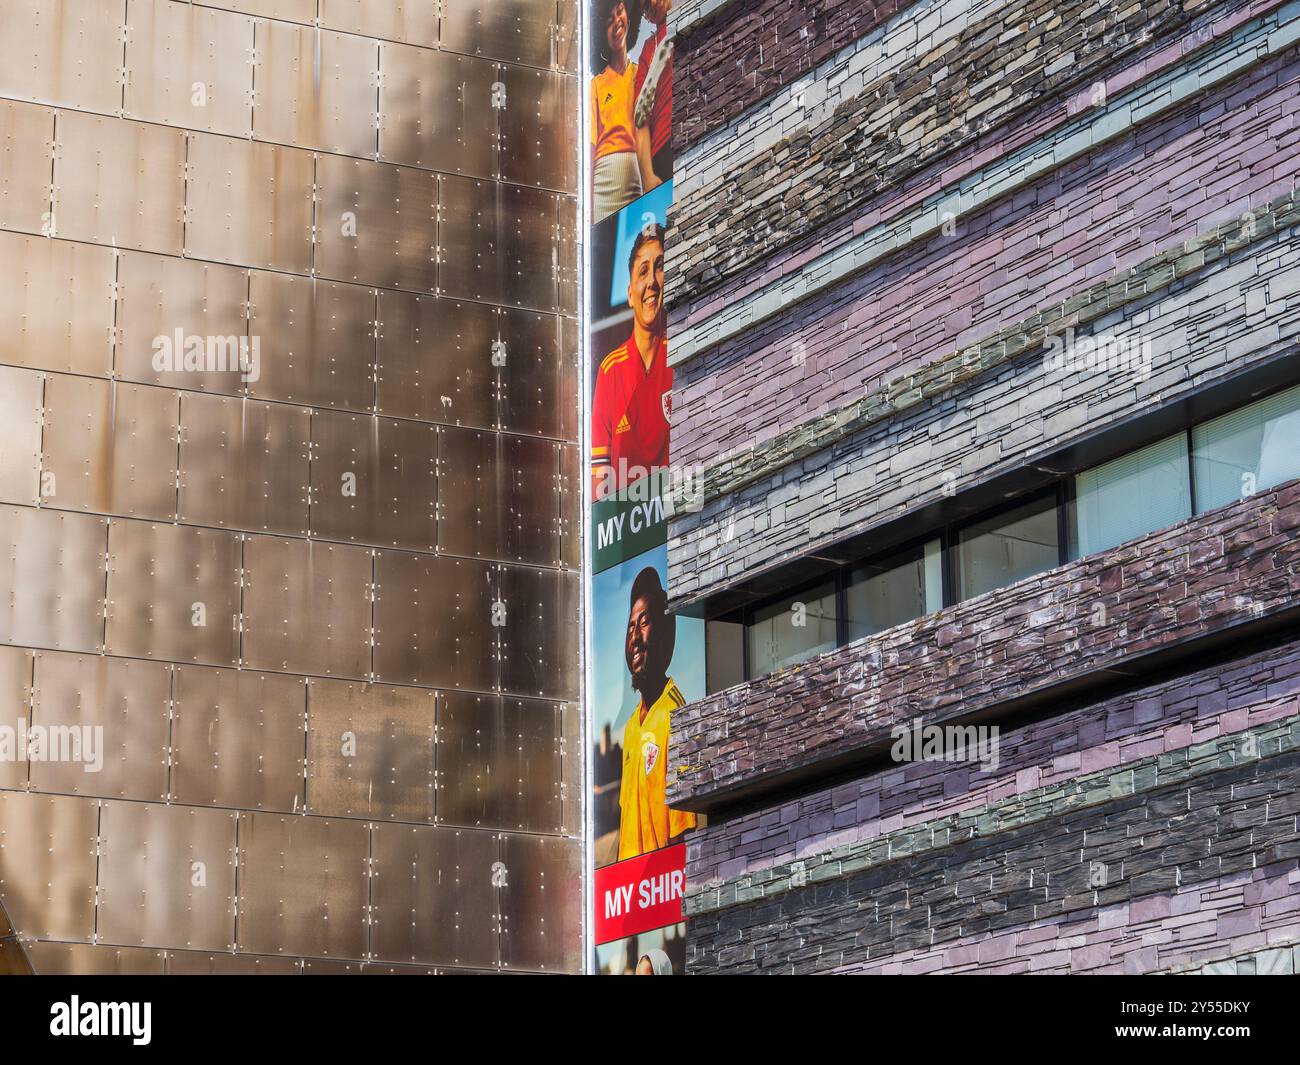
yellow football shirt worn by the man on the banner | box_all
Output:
[619,677,696,862]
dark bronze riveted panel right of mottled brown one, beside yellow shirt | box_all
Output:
[438,692,562,832]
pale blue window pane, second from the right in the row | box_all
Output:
[1075,433,1192,555]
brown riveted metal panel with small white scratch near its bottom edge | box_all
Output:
[378,293,508,429]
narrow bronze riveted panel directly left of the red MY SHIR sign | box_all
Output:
[501,834,582,973]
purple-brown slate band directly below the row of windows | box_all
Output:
[668,481,1300,810]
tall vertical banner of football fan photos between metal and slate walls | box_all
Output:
[585,0,705,975]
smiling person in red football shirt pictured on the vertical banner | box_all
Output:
[592,224,672,499]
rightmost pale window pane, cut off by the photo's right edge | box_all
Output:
[1192,385,1300,514]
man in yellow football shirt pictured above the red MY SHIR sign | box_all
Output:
[619,566,696,861]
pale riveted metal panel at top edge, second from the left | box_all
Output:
[125,0,254,137]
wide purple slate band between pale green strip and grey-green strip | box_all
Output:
[673,44,1300,463]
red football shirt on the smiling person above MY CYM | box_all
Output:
[592,337,672,490]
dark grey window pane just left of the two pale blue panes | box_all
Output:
[957,494,1061,599]
